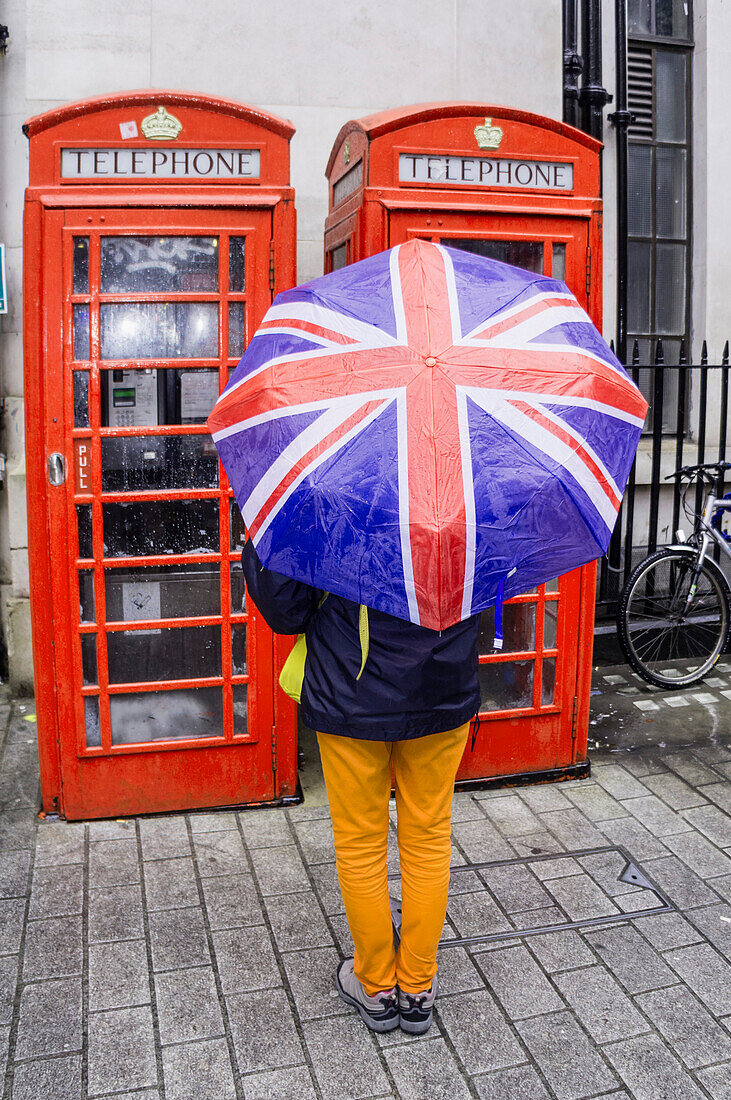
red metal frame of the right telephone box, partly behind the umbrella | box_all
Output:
[324,103,601,782]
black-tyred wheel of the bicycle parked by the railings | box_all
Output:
[617,549,730,688]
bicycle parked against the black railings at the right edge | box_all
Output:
[617,462,731,688]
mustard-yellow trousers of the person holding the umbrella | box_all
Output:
[318,723,469,996]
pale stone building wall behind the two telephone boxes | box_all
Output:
[0,0,731,685]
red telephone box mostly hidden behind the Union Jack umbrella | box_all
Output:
[325,103,601,785]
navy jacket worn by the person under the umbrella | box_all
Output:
[242,541,479,741]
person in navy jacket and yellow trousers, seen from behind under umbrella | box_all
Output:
[242,540,479,1034]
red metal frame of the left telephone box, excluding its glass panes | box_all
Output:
[25,92,297,817]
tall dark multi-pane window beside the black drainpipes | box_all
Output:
[628,0,693,374]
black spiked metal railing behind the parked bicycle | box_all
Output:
[597,340,730,619]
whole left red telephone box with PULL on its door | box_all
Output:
[24,92,297,818]
